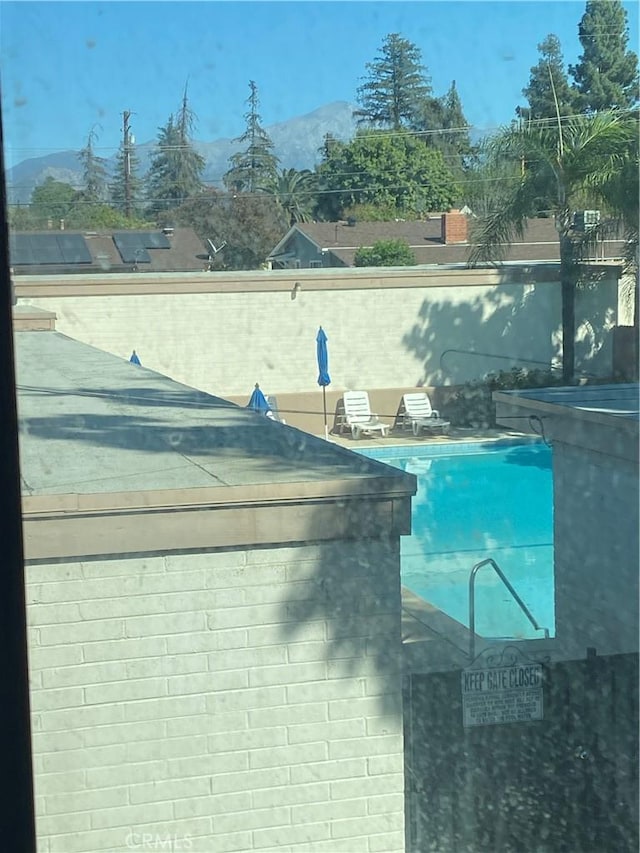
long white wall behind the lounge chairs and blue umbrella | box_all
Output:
[18,271,617,397]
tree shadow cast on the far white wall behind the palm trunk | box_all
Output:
[402,271,615,385]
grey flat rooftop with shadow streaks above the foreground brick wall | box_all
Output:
[15,331,415,499]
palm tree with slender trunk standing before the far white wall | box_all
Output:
[470,111,637,384]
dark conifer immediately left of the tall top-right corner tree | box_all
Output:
[518,33,576,121]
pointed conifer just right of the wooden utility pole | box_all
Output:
[147,88,205,214]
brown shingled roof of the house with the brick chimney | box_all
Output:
[271,215,624,266]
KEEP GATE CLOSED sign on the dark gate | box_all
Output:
[462,663,543,728]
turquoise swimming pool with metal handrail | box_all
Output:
[360,440,555,639]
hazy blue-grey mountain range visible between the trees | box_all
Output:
[6,101,356,204]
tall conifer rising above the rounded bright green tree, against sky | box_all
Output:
[354,33,431,130]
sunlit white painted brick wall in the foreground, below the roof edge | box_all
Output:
[27,540,404,853]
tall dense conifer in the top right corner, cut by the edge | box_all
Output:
[569,0,638,112]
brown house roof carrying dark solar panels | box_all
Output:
[9,228,206,275]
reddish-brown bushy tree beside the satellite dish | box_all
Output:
[166,190,288,270]
